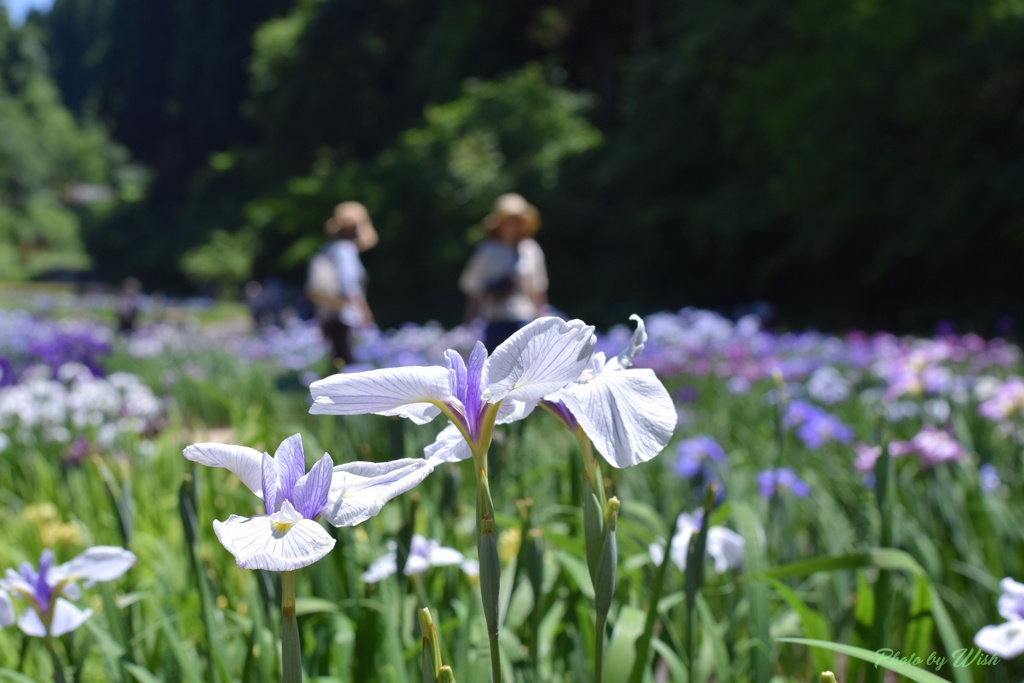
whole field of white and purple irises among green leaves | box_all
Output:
[0,294,1024,683]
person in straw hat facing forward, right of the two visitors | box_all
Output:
[459,193,548,351]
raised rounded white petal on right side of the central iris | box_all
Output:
[483,317,596,403]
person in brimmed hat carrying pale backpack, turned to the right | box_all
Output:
[306,202,378,370]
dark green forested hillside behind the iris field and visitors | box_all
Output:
[0,0,1024,333]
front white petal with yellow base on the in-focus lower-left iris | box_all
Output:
[213,515,335,571]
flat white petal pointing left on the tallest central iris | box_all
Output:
[309,367,452,424]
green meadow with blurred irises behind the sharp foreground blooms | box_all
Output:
[0,290,1024,682]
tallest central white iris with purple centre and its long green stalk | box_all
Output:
[309,317,595,683]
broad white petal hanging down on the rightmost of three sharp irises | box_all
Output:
[549,369,678,467]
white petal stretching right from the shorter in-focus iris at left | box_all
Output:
[321,458,434,526]
